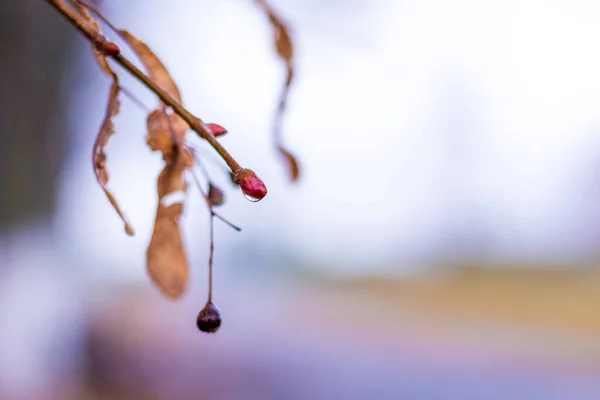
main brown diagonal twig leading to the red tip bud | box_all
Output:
[45,0,242,173]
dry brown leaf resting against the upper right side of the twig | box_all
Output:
[119,29,181,103]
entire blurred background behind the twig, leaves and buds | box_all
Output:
[0,0,600,400]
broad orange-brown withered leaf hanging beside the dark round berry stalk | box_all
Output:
[146,149,193,299]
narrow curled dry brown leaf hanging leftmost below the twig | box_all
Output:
[92,79,134,236]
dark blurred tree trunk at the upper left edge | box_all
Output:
[0,0,76,230]
